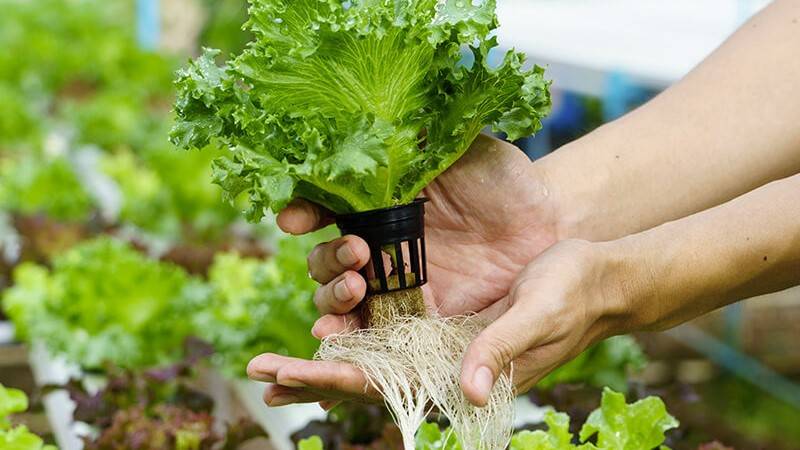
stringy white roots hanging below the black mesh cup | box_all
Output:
[317,316,514,450]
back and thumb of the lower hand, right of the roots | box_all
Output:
[461,240,648,406]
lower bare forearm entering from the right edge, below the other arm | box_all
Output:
[598,175,800,329]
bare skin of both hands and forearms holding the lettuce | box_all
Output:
[248,0,800,407]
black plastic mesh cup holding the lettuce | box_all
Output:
[336,199,428,295]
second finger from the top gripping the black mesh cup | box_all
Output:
[308,235,369,283]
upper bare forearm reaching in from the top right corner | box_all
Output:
[535,0,800,240]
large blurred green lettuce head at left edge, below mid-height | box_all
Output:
[3,238,197,369]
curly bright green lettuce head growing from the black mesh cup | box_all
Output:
[171,0,550,220]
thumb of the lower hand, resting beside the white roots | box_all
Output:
[461,298,534,407]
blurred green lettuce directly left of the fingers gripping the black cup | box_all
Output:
[192,229,333,377]
